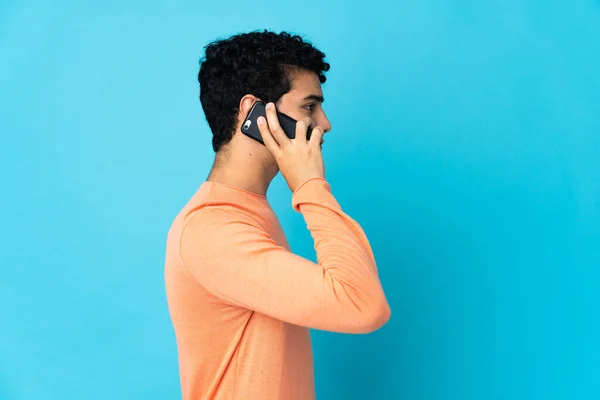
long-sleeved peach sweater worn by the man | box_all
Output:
[165,178,390,400]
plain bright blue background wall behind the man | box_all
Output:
[0,0,600,400]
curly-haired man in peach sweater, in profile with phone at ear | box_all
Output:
[165,31,390,400]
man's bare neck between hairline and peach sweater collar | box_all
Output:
[207,145,278,196]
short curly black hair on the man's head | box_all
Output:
[198,30,329,152]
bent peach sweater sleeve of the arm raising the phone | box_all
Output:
[180,179,390,333]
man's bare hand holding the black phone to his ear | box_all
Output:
[256,103,325,192]
